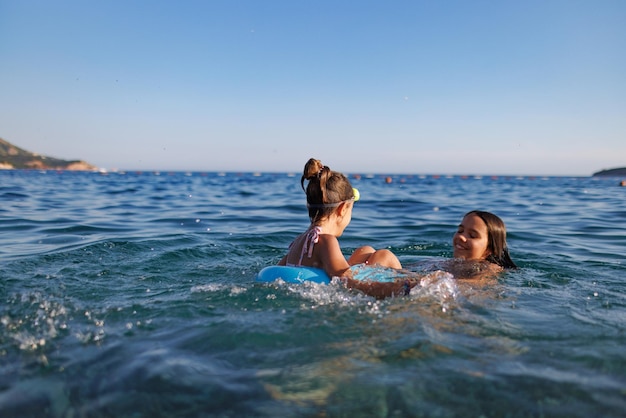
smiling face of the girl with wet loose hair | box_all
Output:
[452,213,491,260]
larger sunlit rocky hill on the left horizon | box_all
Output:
[0,138,98,171]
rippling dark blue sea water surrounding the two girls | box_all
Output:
[0,171,626,418]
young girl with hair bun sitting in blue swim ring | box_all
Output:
[278,158,402,277]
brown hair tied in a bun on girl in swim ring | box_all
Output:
[300,158,354,223]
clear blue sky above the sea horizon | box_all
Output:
[0,0,626,175]
